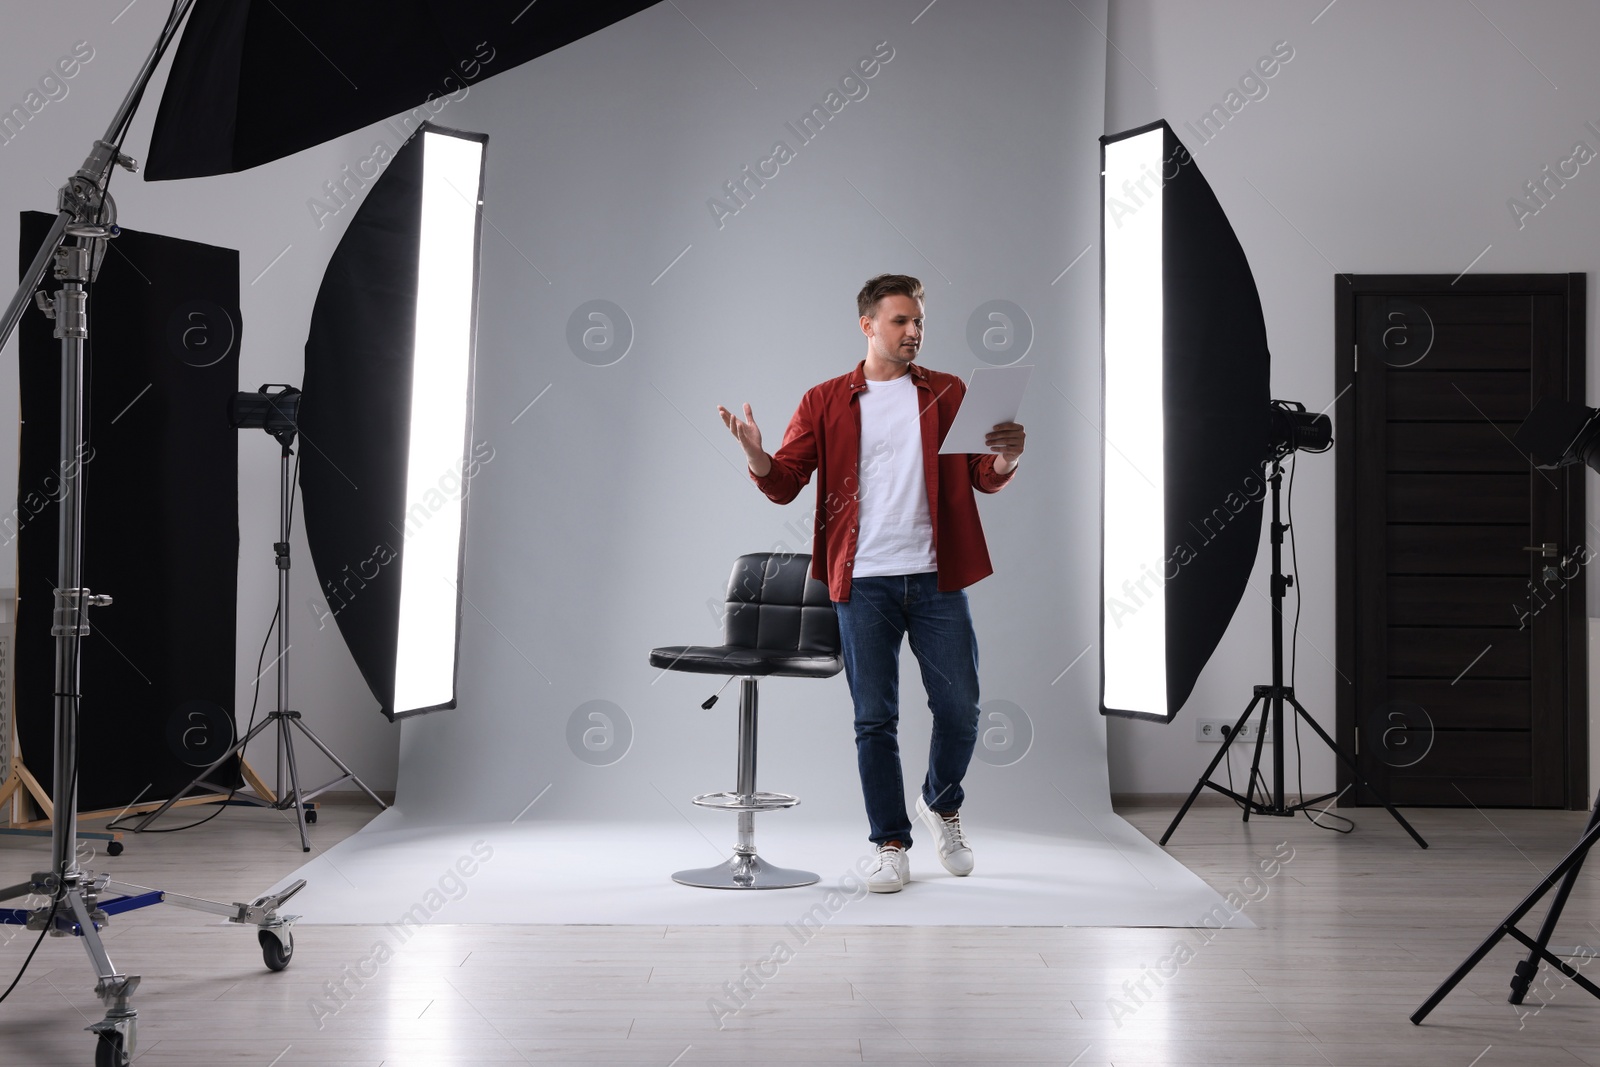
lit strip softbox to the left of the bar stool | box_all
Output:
[299,125,486,718]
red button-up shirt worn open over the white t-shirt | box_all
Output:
[747,360,1016,600]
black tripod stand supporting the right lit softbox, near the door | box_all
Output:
[1160,450,1427,848]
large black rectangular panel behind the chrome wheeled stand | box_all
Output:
[15,211,241,809]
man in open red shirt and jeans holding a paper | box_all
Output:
[717,274,1024,893]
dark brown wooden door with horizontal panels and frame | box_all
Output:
[1334,274,1594,809]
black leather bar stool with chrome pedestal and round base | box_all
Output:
[650,552,845,889]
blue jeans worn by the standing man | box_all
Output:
[834,573,978,848]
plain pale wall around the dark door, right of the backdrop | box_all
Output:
[1106,0,1600,792]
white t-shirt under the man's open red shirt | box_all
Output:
[851,373,939,577]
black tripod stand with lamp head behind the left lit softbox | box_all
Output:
[134,384,389,853]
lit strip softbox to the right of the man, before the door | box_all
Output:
[1101,122,1270,721]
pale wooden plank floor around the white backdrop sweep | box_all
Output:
[0,798,1600,1067]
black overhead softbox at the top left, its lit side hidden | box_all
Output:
[144,0,658,181]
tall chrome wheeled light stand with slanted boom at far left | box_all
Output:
[0,0,306,1067]
